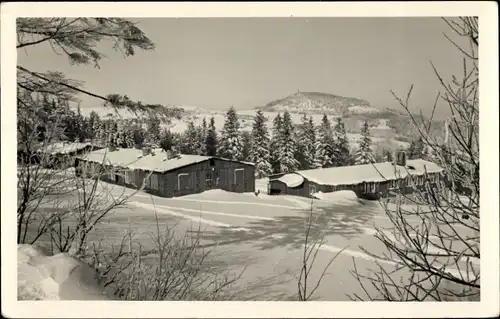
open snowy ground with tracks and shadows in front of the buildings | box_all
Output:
[23,180,476,301]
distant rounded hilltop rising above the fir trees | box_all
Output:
[258,91,380,116]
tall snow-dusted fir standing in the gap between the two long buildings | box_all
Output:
[250,110,272,178]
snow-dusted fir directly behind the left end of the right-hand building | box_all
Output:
[278,111,299,172]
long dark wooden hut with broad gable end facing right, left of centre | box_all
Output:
[76,148,255,197]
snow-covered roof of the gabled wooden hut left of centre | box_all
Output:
[80,148,254,173]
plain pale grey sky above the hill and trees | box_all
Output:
[18,18,468,116]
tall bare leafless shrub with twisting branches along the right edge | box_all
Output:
[351,17,480,301]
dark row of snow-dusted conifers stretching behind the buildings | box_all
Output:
[25,96,427,178]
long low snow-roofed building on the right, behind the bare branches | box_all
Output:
[268,154,443,198]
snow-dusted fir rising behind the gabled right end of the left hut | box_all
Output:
[218,107,243,160]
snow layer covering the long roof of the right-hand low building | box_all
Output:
[277,159,442,187]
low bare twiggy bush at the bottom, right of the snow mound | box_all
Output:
[86,211,243,300]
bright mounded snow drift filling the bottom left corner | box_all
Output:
[17,245,111,300]
